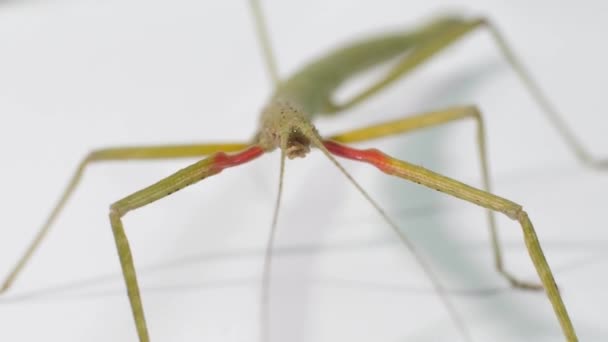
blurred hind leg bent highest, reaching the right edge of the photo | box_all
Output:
[328,17,608,169]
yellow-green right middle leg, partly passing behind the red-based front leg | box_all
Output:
[329,106,543,290]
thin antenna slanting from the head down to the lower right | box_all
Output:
[312,136,473,342]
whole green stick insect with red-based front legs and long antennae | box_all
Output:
[0,0,607,342]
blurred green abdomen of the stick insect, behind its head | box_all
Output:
[275,17,481,116]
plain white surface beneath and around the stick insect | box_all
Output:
[0,0,608,342]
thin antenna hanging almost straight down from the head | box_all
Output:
[260,149,285,342]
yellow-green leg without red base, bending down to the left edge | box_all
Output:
[0,143,247,294]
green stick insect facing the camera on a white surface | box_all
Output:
[3,2,592,341]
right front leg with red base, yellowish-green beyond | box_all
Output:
[324,140,578,342]
